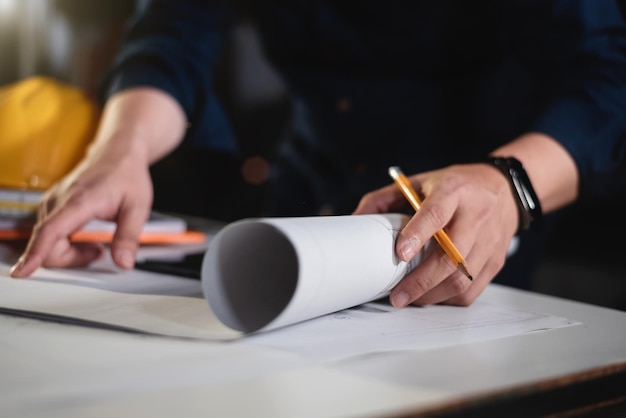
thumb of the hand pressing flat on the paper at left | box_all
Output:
[111,207,150,269]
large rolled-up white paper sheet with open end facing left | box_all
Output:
[201,214,424,333]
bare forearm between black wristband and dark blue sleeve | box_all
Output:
[491,132,579,213]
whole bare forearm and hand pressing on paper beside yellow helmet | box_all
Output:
[11,88,186,277]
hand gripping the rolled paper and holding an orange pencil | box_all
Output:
[354,164,518,307]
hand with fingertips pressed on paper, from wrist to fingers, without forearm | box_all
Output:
[11,142,152,277]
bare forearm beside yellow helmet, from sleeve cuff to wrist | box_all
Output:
[87,87,187,164]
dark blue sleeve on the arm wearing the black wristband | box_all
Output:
[503,0,626,199]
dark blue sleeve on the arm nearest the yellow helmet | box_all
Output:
[101,0,234,151]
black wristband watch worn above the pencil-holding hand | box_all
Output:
[486,157,542,235]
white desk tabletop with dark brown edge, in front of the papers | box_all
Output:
[0,270,626,418]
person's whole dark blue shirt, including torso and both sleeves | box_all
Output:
[106,0,626,215]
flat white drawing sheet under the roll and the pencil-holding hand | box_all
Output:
[241,298,580,361]
